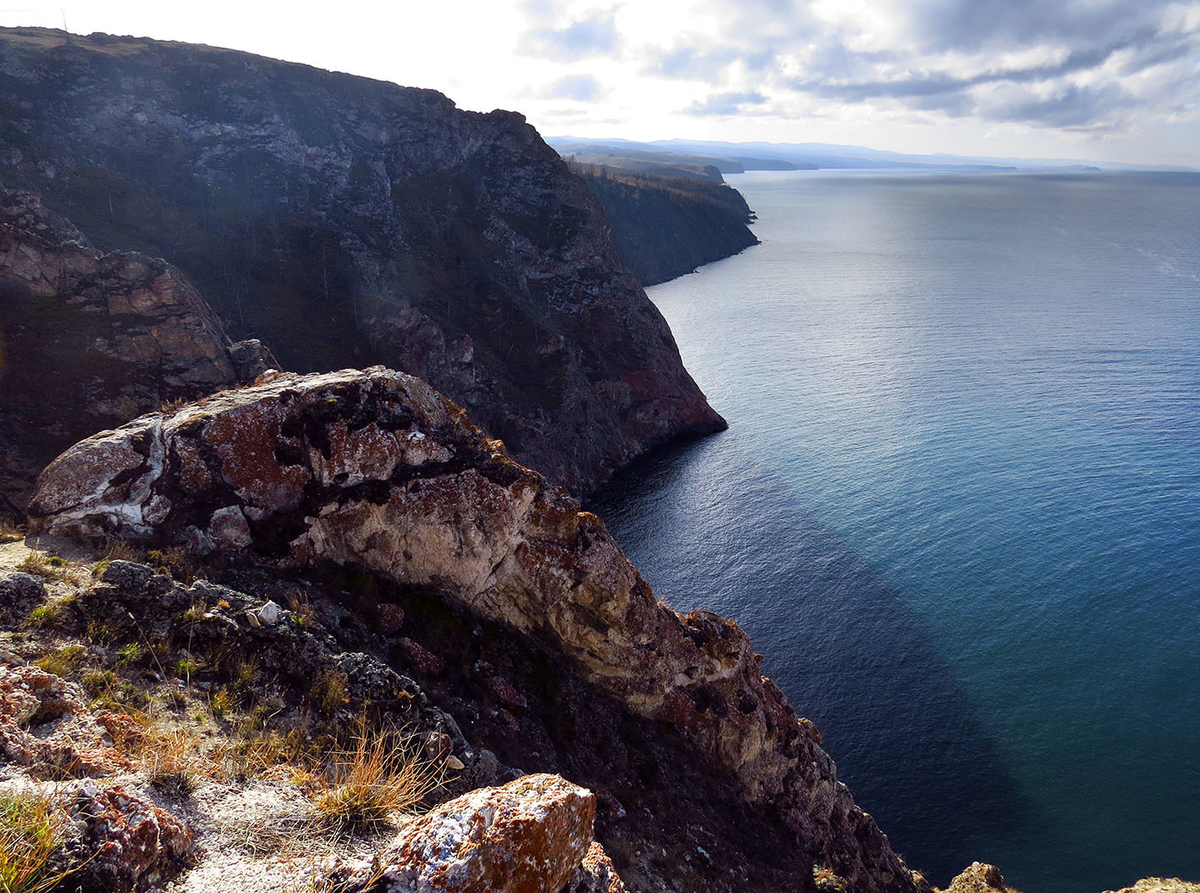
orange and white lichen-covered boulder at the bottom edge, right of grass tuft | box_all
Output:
[340,775,595,893]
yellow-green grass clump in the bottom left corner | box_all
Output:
[0,793,67,893]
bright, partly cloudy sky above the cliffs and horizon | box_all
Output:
[0,0,1200,166]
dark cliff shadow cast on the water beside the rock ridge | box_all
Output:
[586,431,1038,886]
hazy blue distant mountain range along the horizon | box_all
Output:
[546,137,1195,174]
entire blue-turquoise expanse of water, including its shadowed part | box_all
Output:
[592,172,1200,893]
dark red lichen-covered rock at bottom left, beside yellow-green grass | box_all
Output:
[62,781,193,893]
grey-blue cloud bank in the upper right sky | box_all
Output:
[640,0,1200,131]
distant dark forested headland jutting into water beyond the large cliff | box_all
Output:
[574,166,758,286]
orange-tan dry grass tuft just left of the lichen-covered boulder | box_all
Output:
[314,729,445,831]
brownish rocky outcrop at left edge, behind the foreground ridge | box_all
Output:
[0,190,275,517]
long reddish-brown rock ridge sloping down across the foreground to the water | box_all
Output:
[30,368,923,891]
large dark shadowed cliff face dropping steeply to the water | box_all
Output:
[0,29,724,490]
